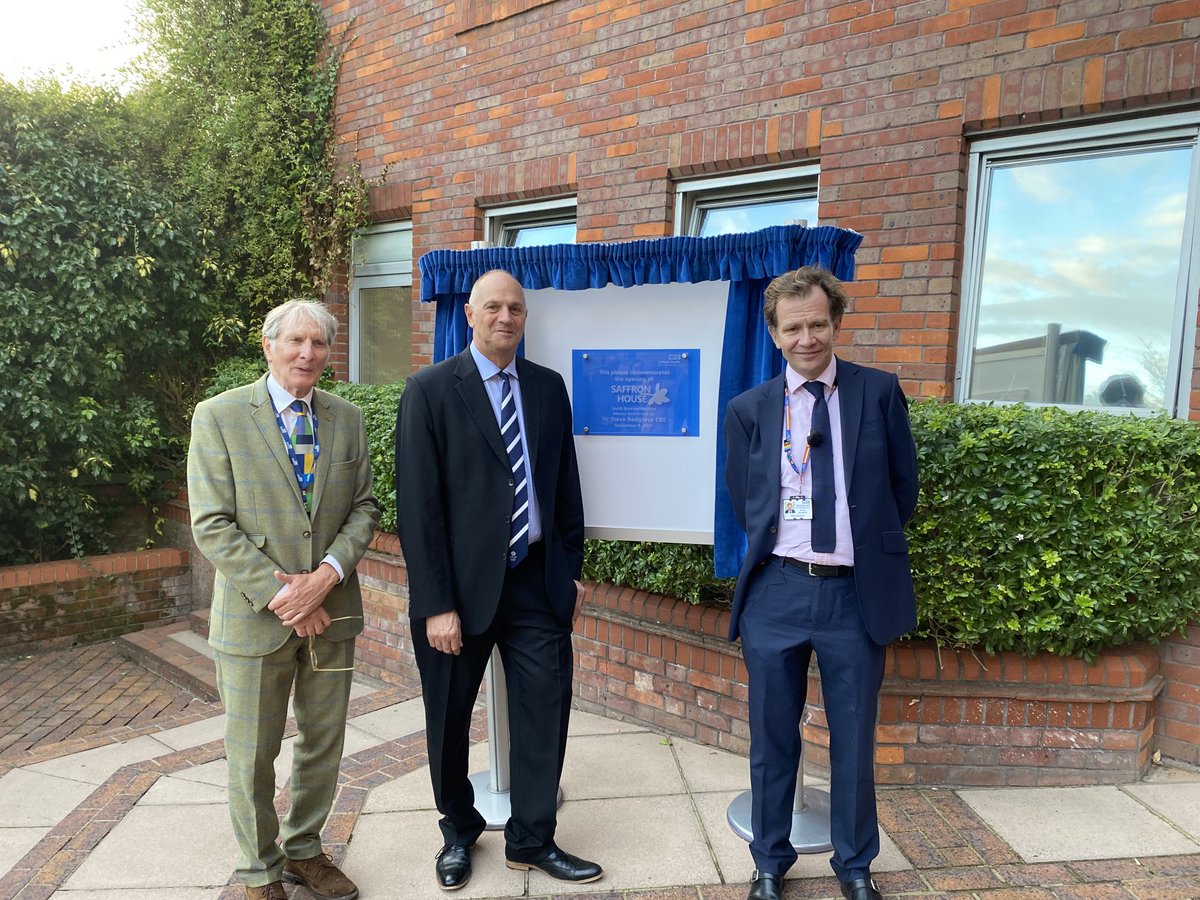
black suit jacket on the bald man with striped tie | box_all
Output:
[396,347,583,635]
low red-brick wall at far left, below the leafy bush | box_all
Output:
[0,548,192,655]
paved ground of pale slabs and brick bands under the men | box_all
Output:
[0,626,1200,900]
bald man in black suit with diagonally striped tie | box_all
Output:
[396,271,601,890]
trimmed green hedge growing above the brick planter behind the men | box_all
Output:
[199,364,1200,659]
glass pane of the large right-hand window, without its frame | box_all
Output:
[970,146,1192,409]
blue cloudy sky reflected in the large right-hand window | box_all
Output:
[976,148,1192,408]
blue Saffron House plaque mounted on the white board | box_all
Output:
[571,349,700,438]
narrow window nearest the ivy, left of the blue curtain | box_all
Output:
[350,222,413,384]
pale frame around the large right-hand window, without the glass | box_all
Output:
[954,112,1200,418]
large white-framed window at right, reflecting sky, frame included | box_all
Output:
[958,113,1200,415]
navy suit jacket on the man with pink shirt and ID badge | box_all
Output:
[725,359,919,644]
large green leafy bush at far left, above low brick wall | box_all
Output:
[0,82,211,564]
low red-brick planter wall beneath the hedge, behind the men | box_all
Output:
[338,534,1200,785]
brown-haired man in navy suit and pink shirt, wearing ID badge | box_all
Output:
[725,266,918,900]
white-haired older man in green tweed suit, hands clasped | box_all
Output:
[187,300,379,900]
